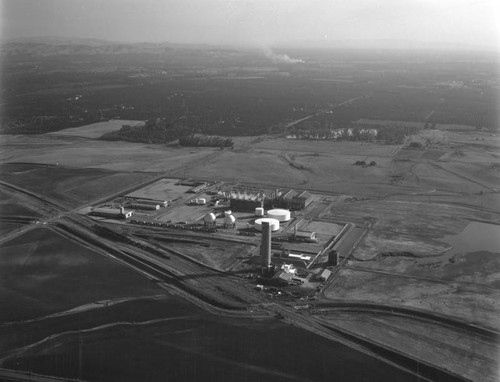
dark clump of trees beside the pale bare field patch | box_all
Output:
[101,118,188,143]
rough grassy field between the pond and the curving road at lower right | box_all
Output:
[325,261,500,330]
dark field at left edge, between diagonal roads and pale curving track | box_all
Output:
[0,228,161,322]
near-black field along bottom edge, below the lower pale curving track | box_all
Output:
[2,310,409,382]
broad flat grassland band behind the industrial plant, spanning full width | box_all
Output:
[0,130,500,197]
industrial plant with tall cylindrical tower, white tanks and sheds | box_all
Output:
[82,178,363,293]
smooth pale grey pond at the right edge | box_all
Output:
[442,222,500,253]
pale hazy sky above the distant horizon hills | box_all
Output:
[1,0,500,47]
